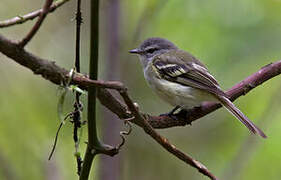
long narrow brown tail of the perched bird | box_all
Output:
[215,96,267,138]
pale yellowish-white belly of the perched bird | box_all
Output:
[146,74,216,109]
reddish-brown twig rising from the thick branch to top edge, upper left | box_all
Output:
[18,0,53,48]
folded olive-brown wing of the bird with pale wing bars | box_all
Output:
[153,50,226,96]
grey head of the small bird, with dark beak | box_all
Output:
[129,38,177,66]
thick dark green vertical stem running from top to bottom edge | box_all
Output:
[80,0,101,180]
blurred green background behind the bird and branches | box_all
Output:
[0,0,281,180]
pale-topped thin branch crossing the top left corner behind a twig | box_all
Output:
[0,0,69,28]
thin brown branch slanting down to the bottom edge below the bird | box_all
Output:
[120,91,218,180]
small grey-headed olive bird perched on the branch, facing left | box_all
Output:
[129,38,266,138]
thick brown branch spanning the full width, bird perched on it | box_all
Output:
[0,35,281,128]
